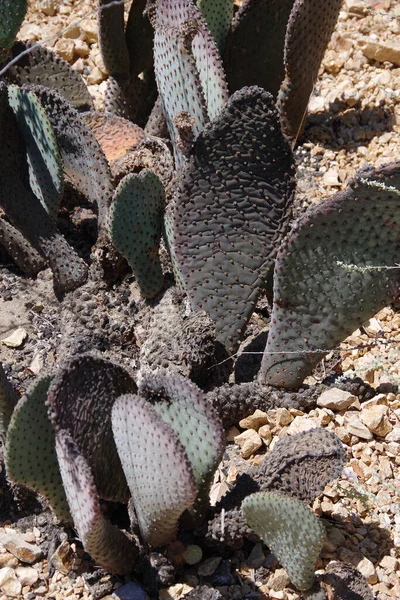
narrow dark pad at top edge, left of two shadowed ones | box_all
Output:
[97,0,129,76]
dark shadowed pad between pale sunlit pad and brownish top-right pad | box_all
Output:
[224,0,294,98]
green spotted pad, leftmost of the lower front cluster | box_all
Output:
[6,375,71,523]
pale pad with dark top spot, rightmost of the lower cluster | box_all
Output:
[139,372,225,508]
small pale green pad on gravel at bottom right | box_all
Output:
[242,492,325,590]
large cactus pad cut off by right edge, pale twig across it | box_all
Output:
[260,162,400,388]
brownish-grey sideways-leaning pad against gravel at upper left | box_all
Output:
[4,42,93,110]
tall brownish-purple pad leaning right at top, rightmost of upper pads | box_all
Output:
[277,0,342,139]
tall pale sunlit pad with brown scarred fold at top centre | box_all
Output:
[154,0,228,165]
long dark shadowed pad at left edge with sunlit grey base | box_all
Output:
[0,83,87,297]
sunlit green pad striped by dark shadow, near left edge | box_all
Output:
[8,85,64,220]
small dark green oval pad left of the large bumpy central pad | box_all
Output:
[110,169,165,298]
